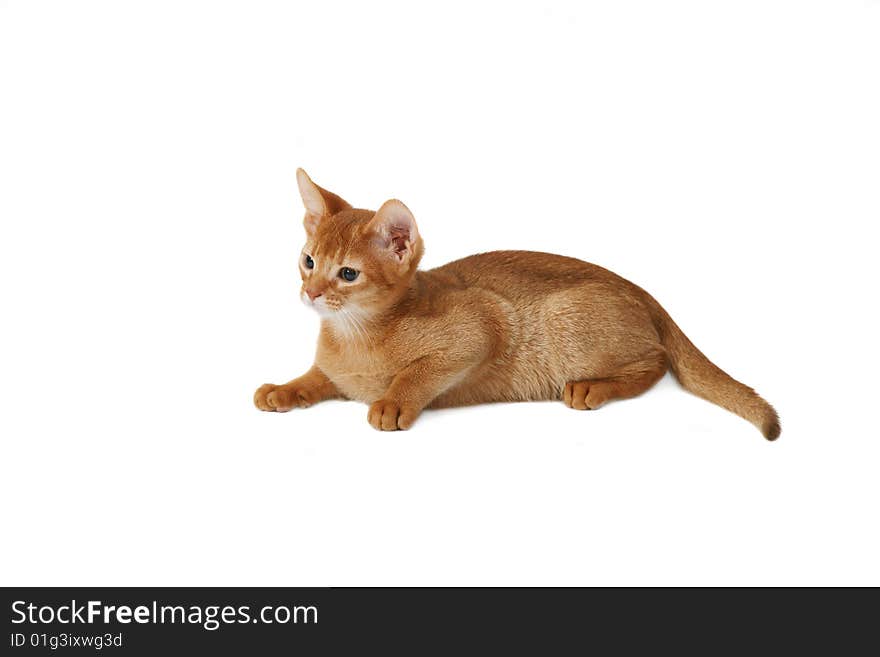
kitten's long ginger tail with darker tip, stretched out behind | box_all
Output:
[649,296,782,440]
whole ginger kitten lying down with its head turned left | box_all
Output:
[254,169,781,440]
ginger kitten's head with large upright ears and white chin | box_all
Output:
[296,169,424,328]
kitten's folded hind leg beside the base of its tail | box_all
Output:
[562,347,668,410]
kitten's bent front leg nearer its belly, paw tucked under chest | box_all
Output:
[367,354,478,431]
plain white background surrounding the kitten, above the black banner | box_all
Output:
[0,0,880,585]
